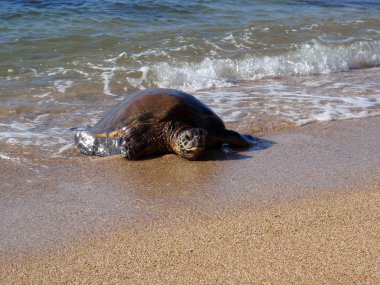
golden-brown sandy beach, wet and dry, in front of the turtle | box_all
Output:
[0,117,380,284]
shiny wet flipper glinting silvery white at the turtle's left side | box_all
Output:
[74,130,126,156]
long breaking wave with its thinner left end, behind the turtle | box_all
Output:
[3,38,380,95]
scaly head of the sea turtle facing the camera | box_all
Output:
[172,128,207,160]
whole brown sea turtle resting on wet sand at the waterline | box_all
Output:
[75,89,255,160]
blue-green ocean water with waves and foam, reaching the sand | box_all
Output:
[0,0,380,159]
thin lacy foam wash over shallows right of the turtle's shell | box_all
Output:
[196,69,380,126]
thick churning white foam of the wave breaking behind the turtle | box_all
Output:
[123,37,380,91]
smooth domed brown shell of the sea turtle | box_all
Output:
[87,89,225,137]
